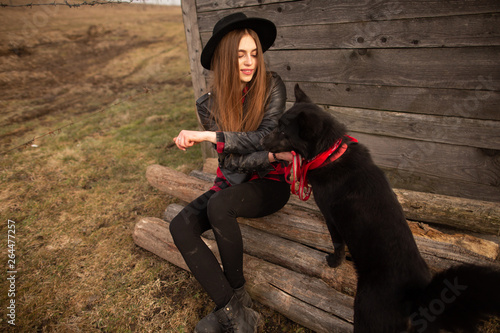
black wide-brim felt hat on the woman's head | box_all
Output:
[201,13,276,69]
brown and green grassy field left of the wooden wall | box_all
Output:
[0,5,310,332]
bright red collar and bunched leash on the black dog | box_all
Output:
[285,135,358,201]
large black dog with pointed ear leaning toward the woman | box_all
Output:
[262,85,500,333]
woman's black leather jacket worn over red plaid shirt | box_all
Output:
[196,72,286,185]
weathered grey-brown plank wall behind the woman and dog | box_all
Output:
[182,0,500,201]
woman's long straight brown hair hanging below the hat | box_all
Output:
[211,29,269,132]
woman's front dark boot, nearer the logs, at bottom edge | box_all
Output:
[215,296,260,333]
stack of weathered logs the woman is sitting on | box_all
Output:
[133,165,500,332]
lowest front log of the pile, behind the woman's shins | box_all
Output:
[133,217,353,332]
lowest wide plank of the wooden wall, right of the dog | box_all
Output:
[351,131,500,202]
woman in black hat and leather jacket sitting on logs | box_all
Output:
[170,13,292,332]
